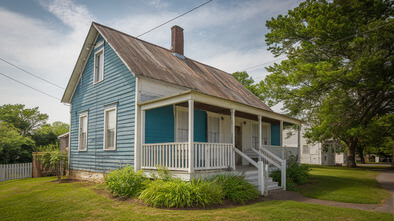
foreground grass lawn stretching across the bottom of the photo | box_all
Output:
[0,177,392,220]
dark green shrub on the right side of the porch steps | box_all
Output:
[270,163,309,190]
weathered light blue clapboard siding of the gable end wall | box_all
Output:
[70,36,135,172]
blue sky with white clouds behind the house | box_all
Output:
[0,0,301,123]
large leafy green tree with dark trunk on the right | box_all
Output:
[260,0,394,167]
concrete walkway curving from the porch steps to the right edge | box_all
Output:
[266,170,394,214]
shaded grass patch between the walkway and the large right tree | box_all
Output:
[294,165,390,204]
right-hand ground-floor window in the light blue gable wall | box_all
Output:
[104,107,116,150]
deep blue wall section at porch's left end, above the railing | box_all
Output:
[145,105,174,143]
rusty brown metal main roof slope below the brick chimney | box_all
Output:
[93,23,272,111]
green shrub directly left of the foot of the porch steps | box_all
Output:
[210,175,260,204]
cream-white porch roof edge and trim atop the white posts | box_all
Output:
[138,90,302,125]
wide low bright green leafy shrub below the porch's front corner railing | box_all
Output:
[139,179,223,208]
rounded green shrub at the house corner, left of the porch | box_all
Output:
[105,165,149,197]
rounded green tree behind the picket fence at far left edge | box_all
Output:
[0,122,34,164]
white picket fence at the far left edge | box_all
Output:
[0,163,33,181]
